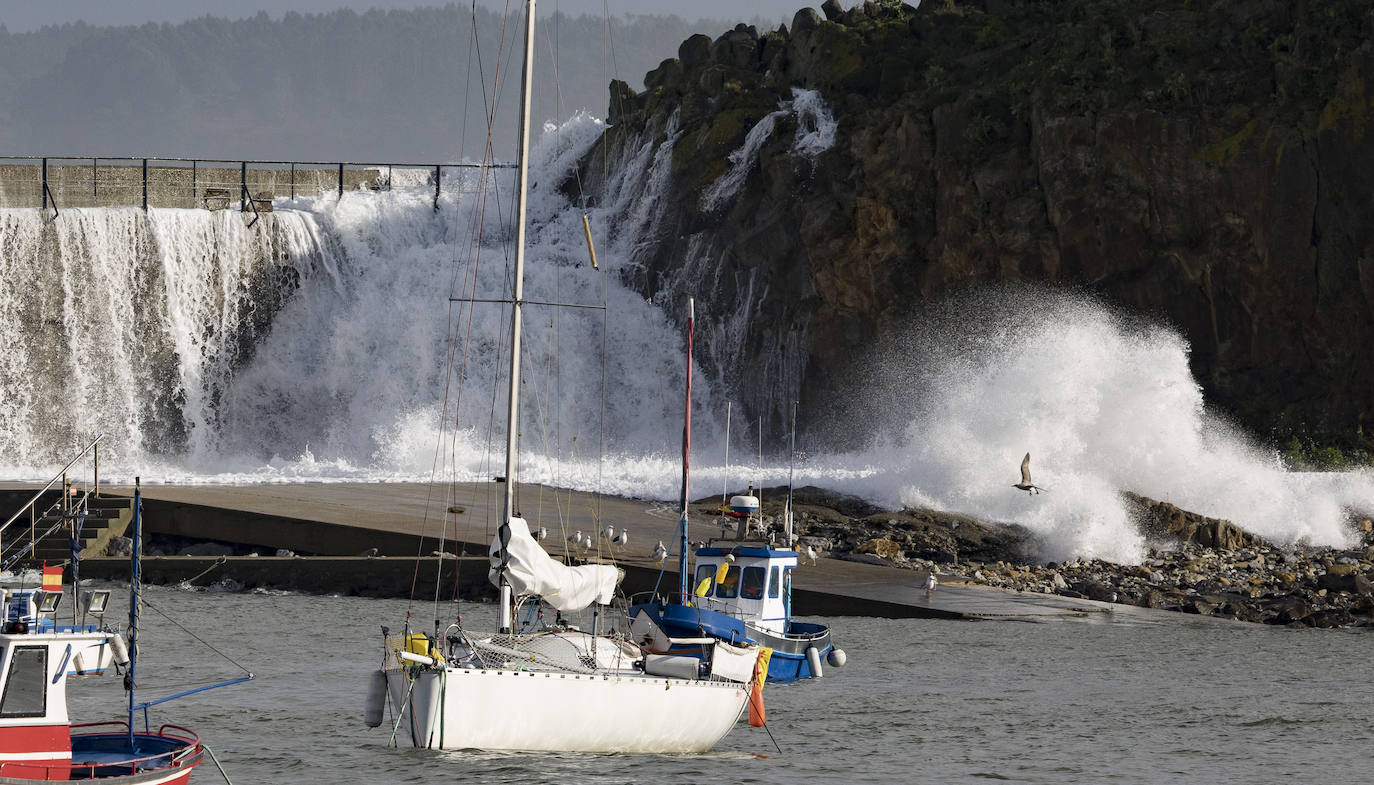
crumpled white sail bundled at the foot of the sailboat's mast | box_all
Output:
[486,518,621,612]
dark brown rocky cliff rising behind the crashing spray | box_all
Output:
[584,0,1374,445]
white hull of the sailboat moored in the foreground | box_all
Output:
[386,667,749,753]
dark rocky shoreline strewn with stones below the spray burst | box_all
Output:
[719,487,1374,628]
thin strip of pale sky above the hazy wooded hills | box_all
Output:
[0,0,807,33]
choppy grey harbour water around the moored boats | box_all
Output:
[73,588,1374,785]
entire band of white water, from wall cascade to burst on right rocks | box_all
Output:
[0,115,1374,561]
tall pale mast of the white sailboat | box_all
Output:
[500,0,534,631]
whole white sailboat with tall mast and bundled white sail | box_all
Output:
[365,0,767,753]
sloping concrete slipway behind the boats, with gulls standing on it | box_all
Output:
[5,483,1179,621]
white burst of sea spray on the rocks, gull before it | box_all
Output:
[813,286,1374,562]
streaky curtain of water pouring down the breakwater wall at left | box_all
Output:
[0,209,322,474]
